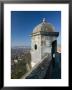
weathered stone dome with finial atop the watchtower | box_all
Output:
[33,18,55,33]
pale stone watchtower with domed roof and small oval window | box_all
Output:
[31,18,59,63]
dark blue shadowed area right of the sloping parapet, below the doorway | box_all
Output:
[44,53,61,79]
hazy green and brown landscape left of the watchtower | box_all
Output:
[11,46,31,79]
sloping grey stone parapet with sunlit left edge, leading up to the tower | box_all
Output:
[22,56,51,79]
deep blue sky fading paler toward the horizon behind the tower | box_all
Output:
[11,11,61,46]
